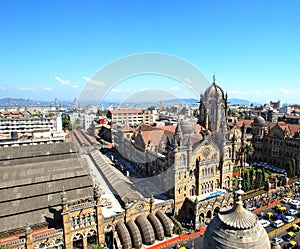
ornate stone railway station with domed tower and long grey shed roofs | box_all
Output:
[0,79,255,249]
